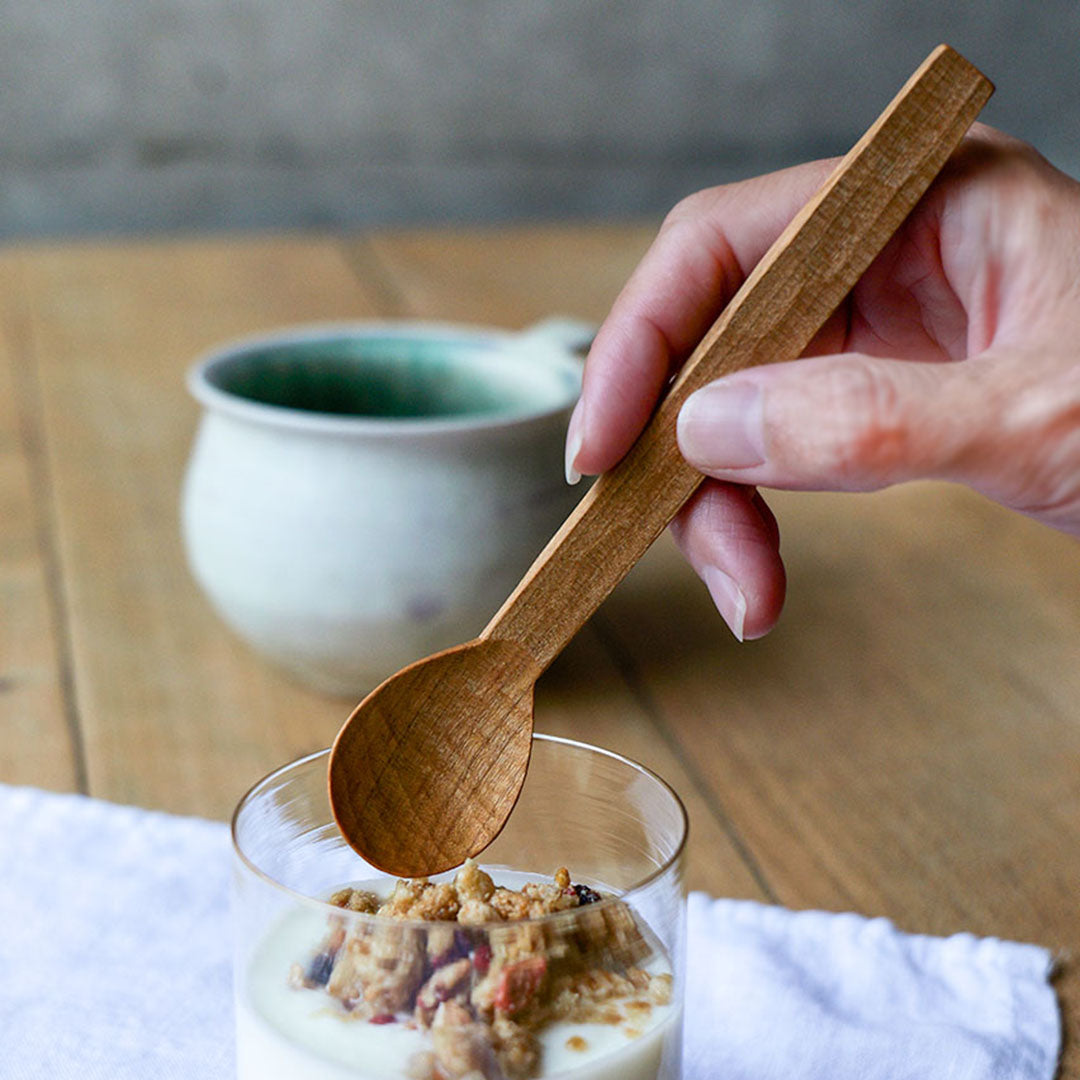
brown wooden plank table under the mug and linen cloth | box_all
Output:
[0,226,1080,1076]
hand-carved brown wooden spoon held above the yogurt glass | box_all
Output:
[329,45,994,877]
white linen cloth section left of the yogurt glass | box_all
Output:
[0,786,235,1080]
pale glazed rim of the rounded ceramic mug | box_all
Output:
[186,320,584,436]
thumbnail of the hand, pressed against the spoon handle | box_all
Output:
[678,382,766,472]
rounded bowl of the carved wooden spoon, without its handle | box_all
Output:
[329,638,539,877]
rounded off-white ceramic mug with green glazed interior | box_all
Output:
[181,320,592,697]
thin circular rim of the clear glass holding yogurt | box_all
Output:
[229,731,690,929]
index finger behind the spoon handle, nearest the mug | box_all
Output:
[568,154,836,473]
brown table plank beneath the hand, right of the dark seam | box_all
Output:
[603,485,1080,1075]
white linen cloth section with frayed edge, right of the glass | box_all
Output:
[685,893,1061,1080]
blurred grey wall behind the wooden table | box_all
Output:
[0,0,1080,241]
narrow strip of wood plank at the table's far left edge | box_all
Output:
[0,252,80,791]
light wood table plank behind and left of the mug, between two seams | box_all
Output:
[12,238,395,816]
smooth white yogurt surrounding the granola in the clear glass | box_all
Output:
[237,885,679,1080]
